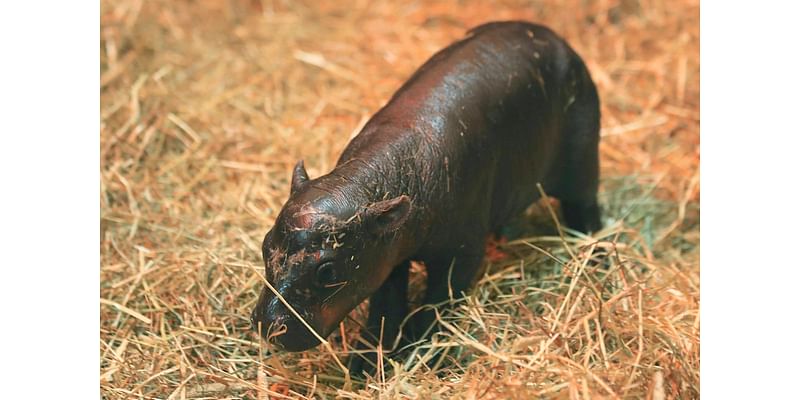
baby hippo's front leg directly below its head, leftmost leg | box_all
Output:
[350,261,411,376]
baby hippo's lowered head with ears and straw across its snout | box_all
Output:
[251,161,410,351]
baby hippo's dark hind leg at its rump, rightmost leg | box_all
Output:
[552,68,602,233]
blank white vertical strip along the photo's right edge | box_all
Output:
[700,1,800,399]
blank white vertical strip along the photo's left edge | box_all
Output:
[0,1,100,399]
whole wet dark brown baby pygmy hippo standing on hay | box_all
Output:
[252,22,600,362]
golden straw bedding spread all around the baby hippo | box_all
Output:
[100,0,700,399]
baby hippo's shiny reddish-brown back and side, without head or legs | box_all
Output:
[340,22,590,242]
